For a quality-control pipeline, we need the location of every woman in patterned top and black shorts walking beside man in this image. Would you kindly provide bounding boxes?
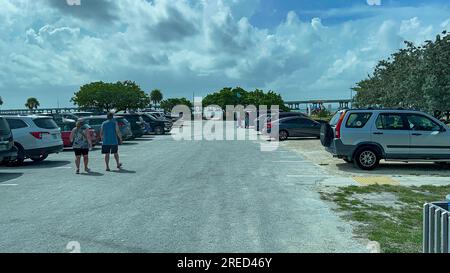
[70,121,92,174]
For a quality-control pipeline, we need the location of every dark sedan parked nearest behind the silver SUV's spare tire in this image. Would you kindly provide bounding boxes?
[264,116,321,141]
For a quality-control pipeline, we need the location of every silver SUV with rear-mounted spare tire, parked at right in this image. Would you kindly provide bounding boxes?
[320,109,450,170]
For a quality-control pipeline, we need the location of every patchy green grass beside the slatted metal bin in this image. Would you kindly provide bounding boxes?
[321,185,450,253]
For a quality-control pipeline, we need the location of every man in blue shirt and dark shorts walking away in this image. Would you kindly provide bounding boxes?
[100,112,122,172]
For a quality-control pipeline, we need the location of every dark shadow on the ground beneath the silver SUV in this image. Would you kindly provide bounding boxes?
[336,162,450,177]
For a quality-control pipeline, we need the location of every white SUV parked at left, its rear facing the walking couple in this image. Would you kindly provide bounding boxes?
[4,115,63,164]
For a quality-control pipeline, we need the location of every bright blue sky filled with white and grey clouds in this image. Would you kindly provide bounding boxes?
[0,0,450,109]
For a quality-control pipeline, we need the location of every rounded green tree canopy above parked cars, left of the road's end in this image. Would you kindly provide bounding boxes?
[72,81,150,111]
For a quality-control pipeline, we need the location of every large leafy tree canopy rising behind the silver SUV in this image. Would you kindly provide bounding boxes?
[352,31,450,116]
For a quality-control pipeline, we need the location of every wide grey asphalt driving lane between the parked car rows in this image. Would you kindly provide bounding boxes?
[0,122,367,253]
